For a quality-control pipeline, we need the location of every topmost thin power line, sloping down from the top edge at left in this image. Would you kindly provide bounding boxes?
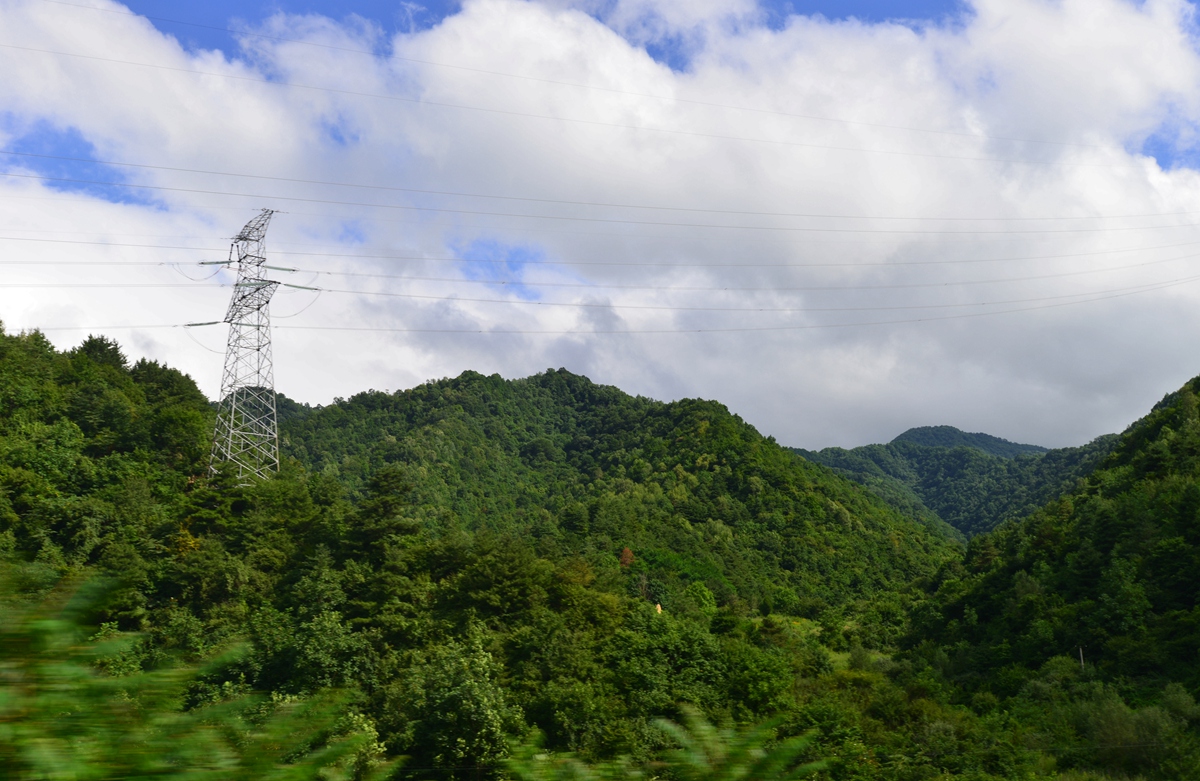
[35,0,1104,149]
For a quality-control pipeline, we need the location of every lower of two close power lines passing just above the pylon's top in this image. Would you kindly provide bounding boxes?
[0,172,1198,236]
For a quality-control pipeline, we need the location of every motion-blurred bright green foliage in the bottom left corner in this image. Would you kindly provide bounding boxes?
[0,566,389,781]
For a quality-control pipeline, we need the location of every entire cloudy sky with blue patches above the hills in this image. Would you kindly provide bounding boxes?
[0,0,1200,447]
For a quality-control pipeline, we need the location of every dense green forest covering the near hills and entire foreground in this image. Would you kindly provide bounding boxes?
[0,321,1200,781]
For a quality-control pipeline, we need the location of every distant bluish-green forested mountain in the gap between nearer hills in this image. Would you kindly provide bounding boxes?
[796,426,1117,536]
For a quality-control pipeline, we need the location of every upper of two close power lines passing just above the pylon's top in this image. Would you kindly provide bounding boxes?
[0,147,1185,222]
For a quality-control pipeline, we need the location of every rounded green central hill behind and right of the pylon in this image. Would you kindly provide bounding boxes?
[282,370,954,633]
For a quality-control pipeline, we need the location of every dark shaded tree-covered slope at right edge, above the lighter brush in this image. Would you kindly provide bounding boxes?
[925,379,1200,687]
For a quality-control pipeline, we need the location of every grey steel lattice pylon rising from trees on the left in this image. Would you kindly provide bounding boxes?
[212,209,280,482]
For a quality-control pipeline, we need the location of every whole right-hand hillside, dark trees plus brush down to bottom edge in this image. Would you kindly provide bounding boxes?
[907,379,1200,779]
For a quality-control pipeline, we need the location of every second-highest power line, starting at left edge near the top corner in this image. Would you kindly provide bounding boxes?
[0,43,1130,169]
